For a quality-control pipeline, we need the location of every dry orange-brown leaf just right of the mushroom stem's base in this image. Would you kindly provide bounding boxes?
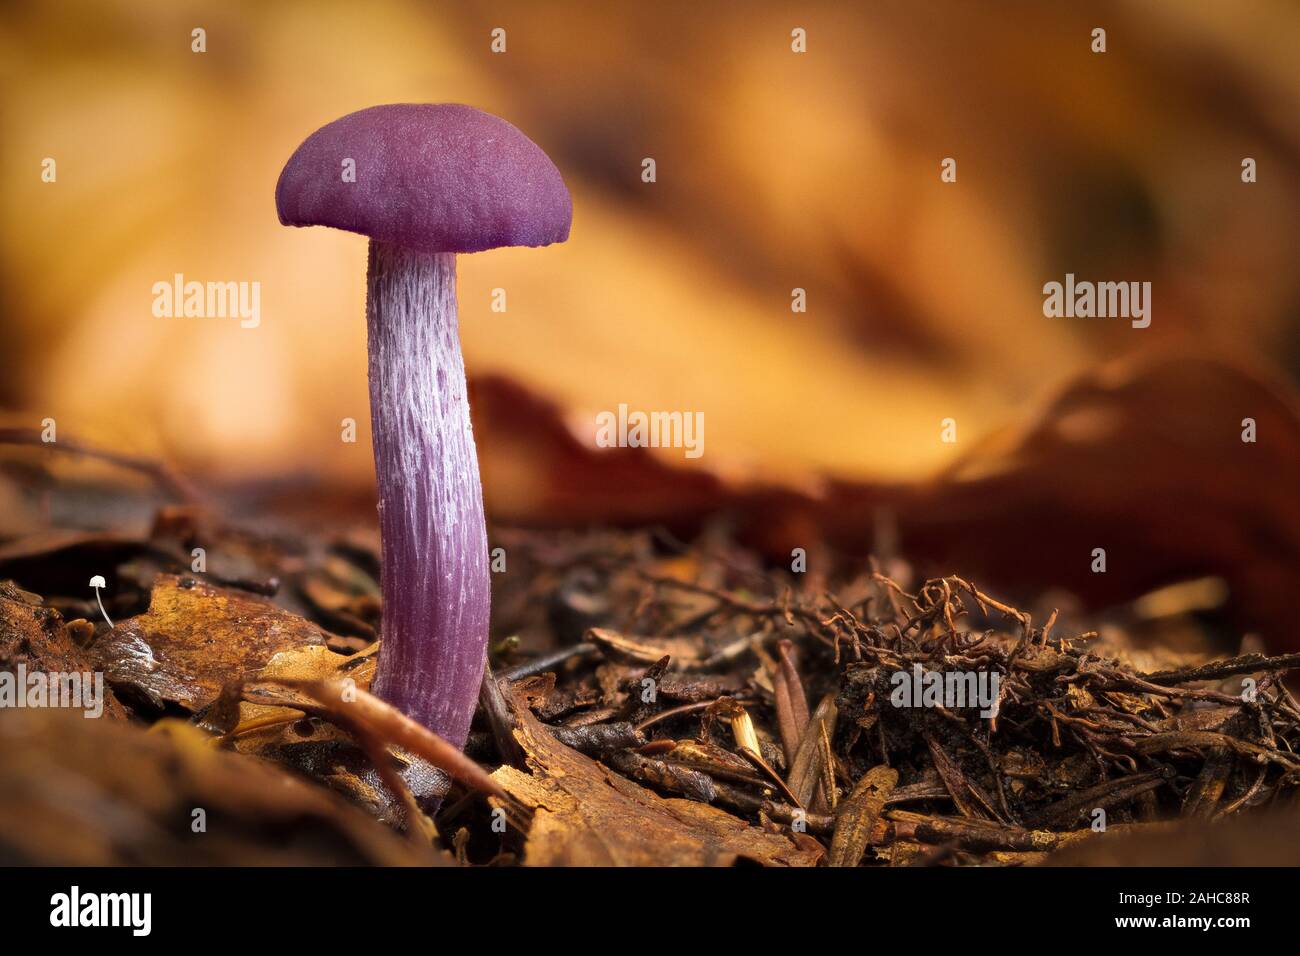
[493,697,820,866]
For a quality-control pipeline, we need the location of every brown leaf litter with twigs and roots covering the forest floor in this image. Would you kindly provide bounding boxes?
[0,510,1300,866]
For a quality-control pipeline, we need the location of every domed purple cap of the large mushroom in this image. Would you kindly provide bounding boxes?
[276,103,573,252]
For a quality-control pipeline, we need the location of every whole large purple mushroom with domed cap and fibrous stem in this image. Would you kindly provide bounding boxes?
[276,104,573,748]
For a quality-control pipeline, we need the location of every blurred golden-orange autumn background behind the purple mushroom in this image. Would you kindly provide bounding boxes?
[0,0,1300,642]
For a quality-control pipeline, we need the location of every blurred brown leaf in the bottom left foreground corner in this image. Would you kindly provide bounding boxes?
[0,710,438,866]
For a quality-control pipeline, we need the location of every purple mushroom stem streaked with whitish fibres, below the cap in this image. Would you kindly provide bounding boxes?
[365,239,491,748]
